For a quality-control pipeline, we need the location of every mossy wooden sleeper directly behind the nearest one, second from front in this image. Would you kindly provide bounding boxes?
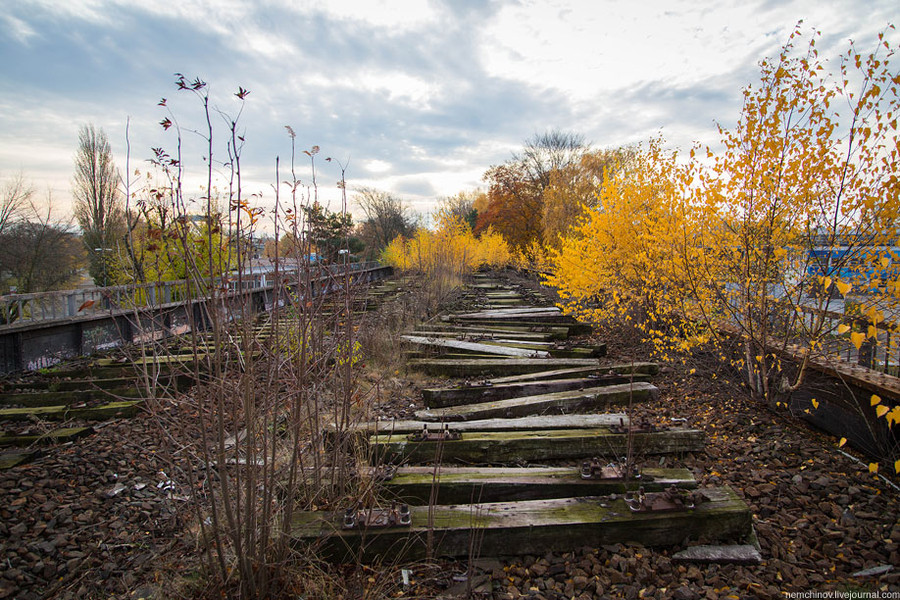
[381,466,697,504]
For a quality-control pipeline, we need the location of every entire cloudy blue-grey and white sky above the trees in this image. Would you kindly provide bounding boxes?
[0,0,897,223]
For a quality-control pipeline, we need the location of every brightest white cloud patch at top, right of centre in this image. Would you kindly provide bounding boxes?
[481,0,886,100]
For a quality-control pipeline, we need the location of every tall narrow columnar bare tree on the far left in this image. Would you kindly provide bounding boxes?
[72,124,125,286]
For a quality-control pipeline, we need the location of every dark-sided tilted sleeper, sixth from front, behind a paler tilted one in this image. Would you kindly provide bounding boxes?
[422,374,650,408]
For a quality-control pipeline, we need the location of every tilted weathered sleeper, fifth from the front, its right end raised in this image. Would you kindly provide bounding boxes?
[416,381,659,421]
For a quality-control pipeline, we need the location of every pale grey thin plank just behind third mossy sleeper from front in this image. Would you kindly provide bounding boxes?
[342,413,629,434]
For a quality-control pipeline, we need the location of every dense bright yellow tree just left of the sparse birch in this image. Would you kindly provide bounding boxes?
[547,139,702,356]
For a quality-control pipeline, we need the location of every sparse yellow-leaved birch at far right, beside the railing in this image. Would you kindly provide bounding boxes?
[689,30,900,400]
